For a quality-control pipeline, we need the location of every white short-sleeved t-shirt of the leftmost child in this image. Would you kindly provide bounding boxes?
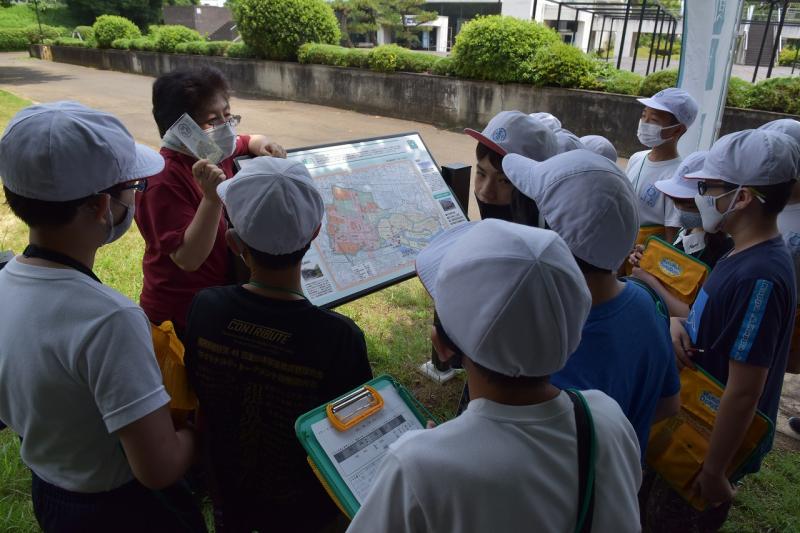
[0,259,169,492]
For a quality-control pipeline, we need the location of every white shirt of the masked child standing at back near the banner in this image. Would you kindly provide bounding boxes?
[625,150,683,228]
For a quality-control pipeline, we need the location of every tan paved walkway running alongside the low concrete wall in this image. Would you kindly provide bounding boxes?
[0,53,800,449]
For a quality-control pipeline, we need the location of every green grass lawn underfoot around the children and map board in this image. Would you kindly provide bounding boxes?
[0,91,800,532]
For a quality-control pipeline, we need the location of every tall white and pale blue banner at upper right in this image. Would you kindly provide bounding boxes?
[678,0,743,156]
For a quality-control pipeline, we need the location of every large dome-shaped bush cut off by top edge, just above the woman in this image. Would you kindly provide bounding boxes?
[233,0,341,60]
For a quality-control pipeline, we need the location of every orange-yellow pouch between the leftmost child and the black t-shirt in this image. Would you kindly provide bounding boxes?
[150,321,198,411]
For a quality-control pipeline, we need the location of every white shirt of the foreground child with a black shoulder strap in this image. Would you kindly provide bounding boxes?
[348,391,642,533]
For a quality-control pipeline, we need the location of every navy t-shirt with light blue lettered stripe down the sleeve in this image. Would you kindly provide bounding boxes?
[686,237,797,472]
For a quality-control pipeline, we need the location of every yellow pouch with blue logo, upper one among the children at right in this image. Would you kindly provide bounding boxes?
[639,237,710,305]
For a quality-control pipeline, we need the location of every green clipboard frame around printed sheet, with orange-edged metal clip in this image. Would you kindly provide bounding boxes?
[294,375,436,519]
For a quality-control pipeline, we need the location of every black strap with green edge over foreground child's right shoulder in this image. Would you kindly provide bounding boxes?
[566,389,597,533]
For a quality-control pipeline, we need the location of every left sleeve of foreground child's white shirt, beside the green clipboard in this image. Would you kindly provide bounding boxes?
[347,452,430,533]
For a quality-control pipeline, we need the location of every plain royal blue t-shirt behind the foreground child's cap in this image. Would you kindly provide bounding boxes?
[551,282,681,457]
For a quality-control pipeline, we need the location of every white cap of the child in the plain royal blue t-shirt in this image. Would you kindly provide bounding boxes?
[503,150,639,271]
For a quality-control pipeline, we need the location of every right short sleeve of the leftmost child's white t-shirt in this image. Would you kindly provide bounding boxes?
[79,308,169,433]
